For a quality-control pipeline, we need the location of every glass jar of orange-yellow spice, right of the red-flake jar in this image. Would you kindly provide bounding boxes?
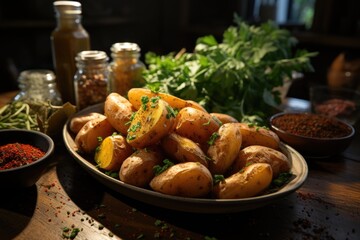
[109,42,145,96]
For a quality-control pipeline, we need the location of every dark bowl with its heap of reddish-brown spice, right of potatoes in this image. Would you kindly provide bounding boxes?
[270,112,355,157]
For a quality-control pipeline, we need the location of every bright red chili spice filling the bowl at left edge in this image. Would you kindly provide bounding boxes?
[0,143,45,170]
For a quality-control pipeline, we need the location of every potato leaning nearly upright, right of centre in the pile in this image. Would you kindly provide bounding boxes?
[207,123,242,174]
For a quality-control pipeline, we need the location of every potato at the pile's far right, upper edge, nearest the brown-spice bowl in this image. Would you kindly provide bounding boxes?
[238,123,280,149]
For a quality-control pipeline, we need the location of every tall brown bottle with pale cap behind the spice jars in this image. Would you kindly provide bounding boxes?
[51,1,90,104]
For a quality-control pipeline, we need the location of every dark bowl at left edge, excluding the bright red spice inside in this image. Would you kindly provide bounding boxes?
[0,129,54,188]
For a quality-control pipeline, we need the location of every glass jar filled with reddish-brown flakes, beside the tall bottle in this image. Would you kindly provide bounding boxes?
[74,51,109,110]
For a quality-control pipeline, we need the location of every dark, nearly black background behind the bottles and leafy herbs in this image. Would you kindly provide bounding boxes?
[0,0,360,95]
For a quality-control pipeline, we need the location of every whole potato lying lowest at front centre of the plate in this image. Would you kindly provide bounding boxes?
[150,162,213,198]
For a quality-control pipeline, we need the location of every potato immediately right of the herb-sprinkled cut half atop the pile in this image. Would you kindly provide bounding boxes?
[175,107,220,144]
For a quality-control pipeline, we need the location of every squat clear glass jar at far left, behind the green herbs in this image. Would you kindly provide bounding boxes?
[14,69,62,106]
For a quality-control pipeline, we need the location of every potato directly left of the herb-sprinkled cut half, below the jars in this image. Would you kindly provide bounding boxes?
[104,93,135,136]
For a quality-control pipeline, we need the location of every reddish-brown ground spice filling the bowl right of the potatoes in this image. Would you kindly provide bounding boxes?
[272,113,351,138]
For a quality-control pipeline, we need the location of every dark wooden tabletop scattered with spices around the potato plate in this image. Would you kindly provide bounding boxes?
[0,92,360,240]
